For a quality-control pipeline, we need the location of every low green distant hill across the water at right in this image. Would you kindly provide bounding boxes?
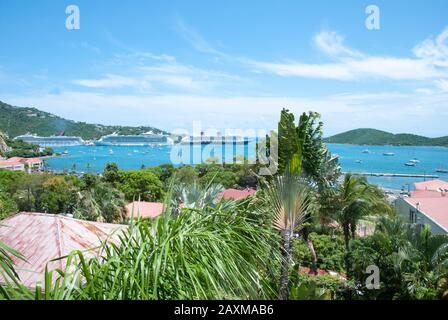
[325,129,448,147]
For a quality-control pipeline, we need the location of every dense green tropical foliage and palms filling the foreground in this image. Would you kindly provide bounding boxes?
[0,110,448,300]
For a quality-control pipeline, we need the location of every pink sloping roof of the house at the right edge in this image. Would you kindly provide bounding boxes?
[404,195,448,230]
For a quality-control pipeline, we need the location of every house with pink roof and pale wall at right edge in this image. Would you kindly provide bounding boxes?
[395,180,448,234]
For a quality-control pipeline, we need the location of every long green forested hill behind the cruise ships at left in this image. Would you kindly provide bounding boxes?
[0,101,167,140]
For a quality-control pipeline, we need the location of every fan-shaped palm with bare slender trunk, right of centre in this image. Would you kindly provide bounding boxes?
[264,174,316,300]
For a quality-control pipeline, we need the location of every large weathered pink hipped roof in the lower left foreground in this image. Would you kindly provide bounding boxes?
[0,213,126,287]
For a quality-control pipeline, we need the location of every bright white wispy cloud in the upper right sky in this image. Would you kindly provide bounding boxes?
[246,30,448,81]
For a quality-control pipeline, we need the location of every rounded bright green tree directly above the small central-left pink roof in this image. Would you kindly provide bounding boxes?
[118,169,164,201]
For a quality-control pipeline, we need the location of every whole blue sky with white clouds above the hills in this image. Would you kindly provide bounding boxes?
[0,0,448,136]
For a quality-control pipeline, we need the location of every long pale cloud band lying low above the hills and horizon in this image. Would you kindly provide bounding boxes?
[6,91,448,136]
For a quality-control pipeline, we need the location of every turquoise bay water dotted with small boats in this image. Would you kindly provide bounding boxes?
[47,142,448,190]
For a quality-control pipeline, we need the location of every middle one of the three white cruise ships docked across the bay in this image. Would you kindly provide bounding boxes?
[95,131,172,146]
